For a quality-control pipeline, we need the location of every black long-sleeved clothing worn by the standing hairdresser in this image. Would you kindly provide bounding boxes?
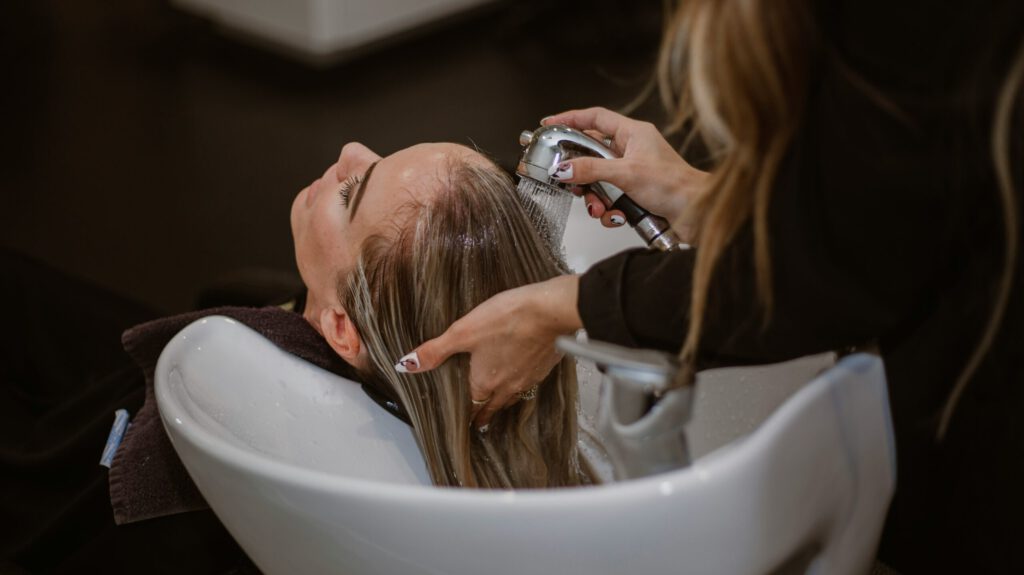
[579,0,1024,573]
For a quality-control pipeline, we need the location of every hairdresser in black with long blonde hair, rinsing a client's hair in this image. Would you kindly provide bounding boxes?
[402,0,1024,573]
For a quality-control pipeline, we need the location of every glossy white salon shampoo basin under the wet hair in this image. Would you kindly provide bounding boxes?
[156,317,895,575]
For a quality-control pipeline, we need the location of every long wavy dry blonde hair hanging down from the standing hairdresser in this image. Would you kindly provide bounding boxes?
[657,0,1024,433]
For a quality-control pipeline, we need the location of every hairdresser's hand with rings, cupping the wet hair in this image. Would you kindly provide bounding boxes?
[395,275,583,427]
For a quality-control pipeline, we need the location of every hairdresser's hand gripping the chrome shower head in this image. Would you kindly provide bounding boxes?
[541,107,708,239]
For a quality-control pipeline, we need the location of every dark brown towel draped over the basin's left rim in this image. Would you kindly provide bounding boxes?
[109,307,355,525]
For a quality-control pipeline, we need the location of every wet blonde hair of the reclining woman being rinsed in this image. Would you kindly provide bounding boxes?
[339,160,591,488]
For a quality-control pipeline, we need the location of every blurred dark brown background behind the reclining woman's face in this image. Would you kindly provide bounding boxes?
[0,0,662,312]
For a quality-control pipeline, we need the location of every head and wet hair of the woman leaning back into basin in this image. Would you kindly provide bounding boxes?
[292,144,592,488]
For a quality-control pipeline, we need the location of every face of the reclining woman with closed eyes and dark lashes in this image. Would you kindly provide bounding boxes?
[291,142,489,319]
